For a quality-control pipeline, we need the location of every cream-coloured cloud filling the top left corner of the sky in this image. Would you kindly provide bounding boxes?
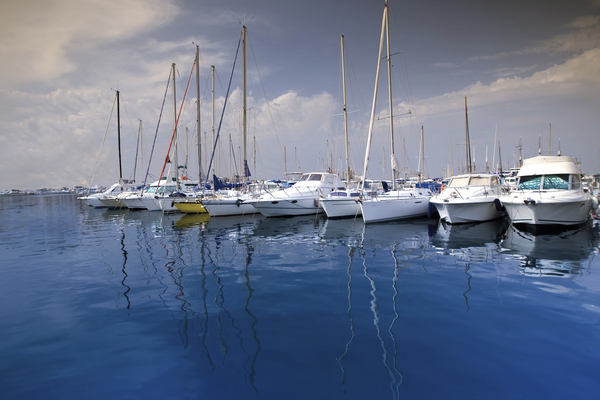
[0,0,178,87]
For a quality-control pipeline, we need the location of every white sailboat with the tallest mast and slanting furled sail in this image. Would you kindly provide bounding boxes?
[359,0,432,223]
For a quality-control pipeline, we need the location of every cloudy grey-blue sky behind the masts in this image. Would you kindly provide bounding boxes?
[0,0,600,190]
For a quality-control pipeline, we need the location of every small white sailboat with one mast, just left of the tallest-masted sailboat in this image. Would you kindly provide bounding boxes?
[320,35,362,218]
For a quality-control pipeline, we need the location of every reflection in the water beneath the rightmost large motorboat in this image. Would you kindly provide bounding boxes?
[502,221,600,278]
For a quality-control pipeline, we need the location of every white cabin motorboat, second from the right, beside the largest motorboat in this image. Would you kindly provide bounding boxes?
[430,173,506,224]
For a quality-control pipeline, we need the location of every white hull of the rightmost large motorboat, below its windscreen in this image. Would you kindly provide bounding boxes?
[503,194,592,226]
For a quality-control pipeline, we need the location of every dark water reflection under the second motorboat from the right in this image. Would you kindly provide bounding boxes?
[431,218,508,249]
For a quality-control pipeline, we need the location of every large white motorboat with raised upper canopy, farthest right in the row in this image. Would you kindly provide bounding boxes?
[500,156,593,229]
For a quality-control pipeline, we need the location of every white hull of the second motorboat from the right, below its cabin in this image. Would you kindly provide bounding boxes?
[430,198,505,224]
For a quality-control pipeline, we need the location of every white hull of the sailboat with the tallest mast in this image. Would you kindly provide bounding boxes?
[360,189,431,223]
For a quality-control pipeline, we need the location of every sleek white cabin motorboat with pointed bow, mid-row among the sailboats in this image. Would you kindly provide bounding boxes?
[244,172,345,217]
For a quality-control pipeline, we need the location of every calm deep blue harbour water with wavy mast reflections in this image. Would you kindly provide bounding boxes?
[0,195,600,399]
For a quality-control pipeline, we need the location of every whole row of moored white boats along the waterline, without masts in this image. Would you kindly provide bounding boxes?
[81,156,600,233]
